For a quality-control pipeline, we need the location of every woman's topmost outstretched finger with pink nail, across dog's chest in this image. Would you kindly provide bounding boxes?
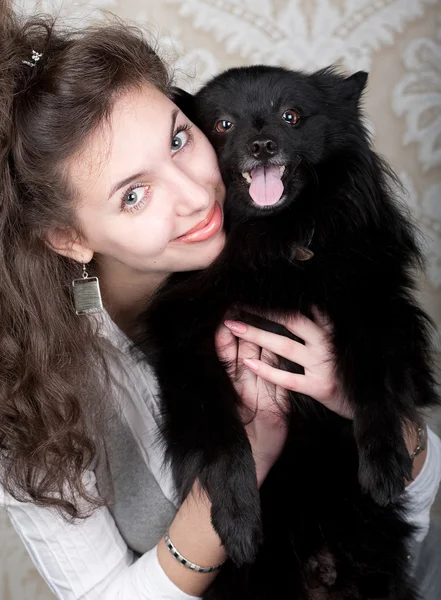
[225,321,309,367]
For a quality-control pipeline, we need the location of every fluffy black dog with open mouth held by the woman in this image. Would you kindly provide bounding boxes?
[138,66,437,600]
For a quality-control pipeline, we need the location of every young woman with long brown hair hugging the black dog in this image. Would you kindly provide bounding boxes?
[0,6,441,600]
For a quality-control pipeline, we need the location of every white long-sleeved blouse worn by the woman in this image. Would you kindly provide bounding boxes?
[0,313,441,600]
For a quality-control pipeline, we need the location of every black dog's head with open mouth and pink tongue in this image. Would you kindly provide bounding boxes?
[174,66,367,213]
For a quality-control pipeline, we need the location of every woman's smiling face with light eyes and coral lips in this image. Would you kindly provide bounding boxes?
[68,85,225,276]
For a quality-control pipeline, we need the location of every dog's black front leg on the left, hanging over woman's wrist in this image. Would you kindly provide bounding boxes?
[137,278,262,565]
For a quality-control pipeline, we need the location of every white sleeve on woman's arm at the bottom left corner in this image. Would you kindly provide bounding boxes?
[0,471,201,600]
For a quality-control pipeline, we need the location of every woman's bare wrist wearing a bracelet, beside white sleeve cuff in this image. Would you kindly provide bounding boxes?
[158,483,227,596]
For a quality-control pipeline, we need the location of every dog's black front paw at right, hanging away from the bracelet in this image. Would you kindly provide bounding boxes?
[358,443,412,506]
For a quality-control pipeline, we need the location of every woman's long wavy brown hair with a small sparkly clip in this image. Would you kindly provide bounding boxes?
[0,0,170,518]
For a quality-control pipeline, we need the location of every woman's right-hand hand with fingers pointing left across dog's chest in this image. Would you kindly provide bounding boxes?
[219,310,353,419]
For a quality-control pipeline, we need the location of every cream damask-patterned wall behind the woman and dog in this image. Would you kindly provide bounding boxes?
[0,0,441,600]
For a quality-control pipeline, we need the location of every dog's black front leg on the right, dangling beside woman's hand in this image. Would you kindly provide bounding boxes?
[331,299,436,505]
